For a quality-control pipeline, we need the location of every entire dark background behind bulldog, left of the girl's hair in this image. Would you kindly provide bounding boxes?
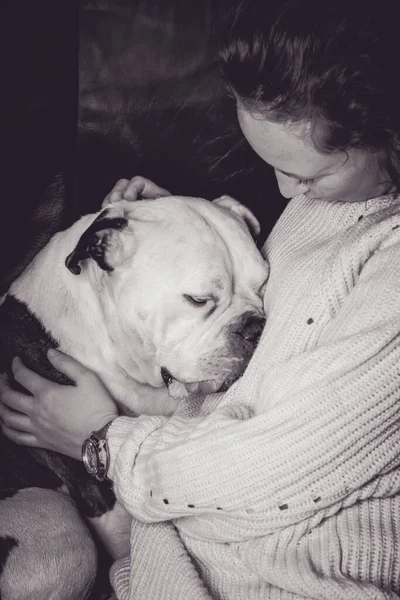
[0,0,285,295]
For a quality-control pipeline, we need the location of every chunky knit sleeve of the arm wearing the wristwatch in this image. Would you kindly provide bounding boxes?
[106,227,400,541]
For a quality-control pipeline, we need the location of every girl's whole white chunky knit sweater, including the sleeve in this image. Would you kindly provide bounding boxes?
[108,196,400,600]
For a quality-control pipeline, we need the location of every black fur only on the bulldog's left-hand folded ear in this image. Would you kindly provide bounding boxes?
[65,209,127,275]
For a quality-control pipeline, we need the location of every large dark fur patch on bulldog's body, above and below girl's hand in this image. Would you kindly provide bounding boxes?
[0,295,115,517]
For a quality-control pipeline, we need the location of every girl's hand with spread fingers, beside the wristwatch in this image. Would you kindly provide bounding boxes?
[0,350,118,460]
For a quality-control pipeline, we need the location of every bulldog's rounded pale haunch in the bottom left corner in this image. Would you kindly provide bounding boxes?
[0,488,97,600]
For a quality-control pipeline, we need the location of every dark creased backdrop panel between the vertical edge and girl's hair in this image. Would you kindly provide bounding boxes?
[79,0,285,236]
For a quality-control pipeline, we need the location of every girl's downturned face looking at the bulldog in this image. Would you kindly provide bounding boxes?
[238,106,391,202]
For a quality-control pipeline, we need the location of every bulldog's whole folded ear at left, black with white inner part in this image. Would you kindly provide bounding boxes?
[65,209,133,275]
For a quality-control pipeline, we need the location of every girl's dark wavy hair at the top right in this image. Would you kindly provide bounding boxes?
[220,0,400,191]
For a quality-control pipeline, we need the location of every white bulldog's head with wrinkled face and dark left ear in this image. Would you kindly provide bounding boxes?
[66,196,268,396]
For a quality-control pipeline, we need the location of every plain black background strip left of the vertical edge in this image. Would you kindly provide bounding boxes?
[0,0,79,295]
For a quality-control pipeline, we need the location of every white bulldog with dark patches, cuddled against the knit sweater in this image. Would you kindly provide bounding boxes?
[0,178,268,600]
